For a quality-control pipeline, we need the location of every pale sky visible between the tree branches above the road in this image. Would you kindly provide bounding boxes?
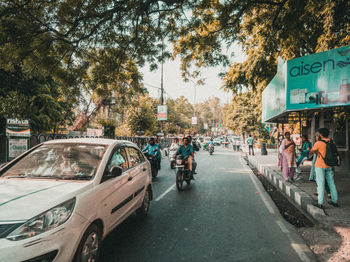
[141,45,246,103]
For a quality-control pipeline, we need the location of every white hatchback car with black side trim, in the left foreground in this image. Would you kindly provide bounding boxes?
[0,138,152,262]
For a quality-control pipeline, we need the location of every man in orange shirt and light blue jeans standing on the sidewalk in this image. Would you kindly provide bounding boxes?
[310,128,339,208]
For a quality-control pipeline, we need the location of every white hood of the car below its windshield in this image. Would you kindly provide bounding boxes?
[0,178,92,222]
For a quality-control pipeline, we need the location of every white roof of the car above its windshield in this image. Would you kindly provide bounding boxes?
[44,137,135,146]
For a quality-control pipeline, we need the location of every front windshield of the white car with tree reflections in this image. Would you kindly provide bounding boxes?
[1,143,107,180]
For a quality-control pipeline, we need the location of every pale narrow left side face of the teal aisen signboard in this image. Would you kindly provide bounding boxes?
[262,57,286,122]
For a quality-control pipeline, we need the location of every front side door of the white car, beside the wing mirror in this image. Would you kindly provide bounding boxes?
[99,145,133,231]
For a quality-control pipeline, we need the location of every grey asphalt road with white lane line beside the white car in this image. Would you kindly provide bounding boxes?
[102,147,313,262]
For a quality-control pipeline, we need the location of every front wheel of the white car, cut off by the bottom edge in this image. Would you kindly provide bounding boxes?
[74,224,102,262]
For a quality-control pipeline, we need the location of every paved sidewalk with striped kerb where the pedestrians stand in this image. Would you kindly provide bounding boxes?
[243,144,350,225]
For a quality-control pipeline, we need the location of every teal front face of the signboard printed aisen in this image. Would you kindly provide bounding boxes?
[286,45,350,110]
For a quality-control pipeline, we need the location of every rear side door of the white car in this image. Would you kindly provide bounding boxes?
[127,146,150,209]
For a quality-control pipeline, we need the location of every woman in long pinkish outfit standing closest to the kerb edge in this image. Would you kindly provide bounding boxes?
[280,132,297,182]
